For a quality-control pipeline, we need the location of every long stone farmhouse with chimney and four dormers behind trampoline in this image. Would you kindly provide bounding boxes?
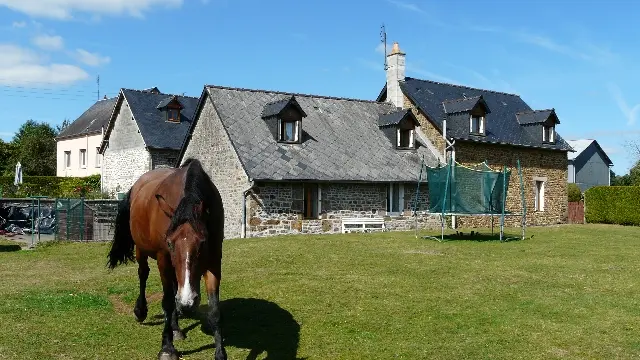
[178,43,572,238]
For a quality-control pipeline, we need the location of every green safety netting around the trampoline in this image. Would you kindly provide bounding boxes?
[425,161,511,214]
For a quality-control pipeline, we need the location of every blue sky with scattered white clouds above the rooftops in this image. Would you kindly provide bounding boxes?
[0,0,640,174]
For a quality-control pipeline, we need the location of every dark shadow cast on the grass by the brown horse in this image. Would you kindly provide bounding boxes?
[147,298,300,360]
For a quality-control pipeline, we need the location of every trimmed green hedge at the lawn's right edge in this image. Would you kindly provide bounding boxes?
[584,186,640,226]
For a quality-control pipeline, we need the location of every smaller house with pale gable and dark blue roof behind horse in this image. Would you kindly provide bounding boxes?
[99,87,198,196]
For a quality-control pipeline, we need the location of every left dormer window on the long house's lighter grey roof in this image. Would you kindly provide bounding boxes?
[261,95,307,144]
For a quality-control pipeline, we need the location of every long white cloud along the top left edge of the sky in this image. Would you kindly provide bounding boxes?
[0,0,184,20]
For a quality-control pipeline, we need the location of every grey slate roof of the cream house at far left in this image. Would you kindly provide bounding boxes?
[58,97,117,139]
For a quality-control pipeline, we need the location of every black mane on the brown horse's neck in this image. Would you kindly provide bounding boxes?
[168,158,220,237]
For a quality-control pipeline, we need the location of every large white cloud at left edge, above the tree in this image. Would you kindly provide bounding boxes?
[0,44,89,86]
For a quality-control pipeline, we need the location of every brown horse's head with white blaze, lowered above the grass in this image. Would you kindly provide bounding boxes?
[156,195,206,312]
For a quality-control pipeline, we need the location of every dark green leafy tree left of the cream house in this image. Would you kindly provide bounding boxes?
[11,120,58,176]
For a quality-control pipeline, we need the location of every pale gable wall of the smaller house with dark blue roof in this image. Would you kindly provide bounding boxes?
[102,99,151,195]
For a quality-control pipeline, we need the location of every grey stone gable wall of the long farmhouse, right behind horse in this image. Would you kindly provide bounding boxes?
[181,97,249,238]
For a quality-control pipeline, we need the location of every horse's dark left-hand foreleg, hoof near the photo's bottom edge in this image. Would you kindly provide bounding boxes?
[158,256,178,360]
